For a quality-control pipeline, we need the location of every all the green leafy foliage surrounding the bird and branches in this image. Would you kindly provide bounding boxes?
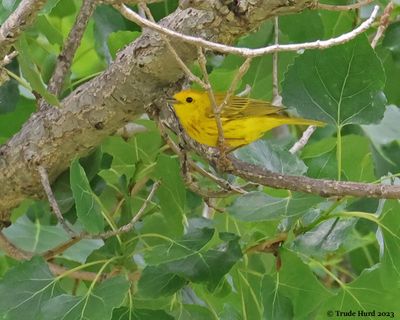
[0,0,400,320]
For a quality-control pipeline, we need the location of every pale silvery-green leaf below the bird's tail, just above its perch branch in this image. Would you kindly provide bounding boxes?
[235,140,307,175]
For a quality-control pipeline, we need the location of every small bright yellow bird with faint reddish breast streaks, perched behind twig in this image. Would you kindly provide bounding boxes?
[171,89,325,148]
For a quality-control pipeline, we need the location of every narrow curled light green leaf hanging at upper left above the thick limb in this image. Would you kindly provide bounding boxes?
[17,36,60,106]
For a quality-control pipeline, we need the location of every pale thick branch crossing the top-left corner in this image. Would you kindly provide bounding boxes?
[0,0,47,60]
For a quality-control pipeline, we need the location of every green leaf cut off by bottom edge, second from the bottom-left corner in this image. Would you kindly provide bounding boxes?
[42,277,129,320]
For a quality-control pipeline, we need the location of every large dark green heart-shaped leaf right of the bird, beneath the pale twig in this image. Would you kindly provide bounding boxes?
[282,36,386,126]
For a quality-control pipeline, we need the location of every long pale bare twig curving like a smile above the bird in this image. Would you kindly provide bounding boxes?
[119,5,379,57]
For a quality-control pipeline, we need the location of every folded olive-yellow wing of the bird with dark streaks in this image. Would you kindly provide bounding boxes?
[209,93,285,118]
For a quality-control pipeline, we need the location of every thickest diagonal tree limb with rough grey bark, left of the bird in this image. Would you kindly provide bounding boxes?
[0,0,312,221]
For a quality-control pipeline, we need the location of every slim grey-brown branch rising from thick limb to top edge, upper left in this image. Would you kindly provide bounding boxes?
[47,0,97,96]
